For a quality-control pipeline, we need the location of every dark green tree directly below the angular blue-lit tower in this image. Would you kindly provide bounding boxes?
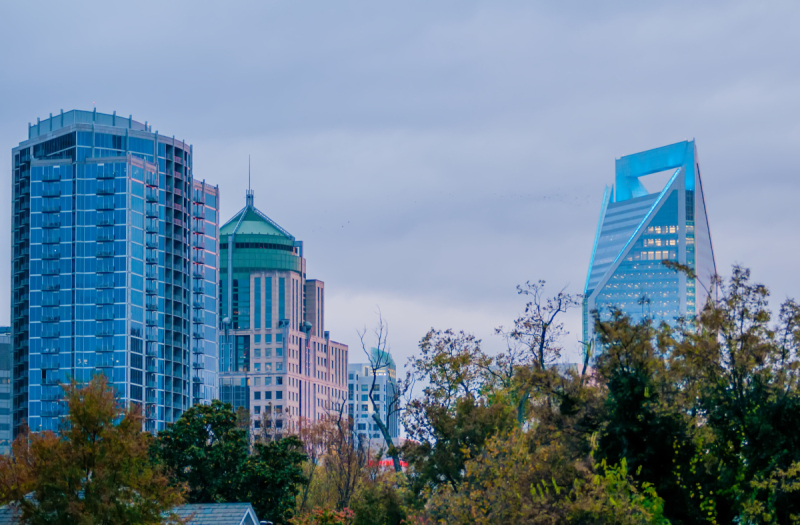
[595,312,711,523]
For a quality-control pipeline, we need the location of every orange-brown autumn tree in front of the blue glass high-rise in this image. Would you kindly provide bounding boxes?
[0,375,183,525]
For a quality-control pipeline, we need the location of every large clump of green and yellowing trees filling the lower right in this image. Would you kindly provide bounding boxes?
[356,265,800,524]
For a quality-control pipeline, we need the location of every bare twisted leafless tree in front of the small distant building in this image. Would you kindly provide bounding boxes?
[358,311,402,473]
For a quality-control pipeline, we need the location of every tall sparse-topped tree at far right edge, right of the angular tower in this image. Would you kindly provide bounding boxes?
[670,267,800,523]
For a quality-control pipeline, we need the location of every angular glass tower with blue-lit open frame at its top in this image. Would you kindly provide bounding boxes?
[583,140,716,342]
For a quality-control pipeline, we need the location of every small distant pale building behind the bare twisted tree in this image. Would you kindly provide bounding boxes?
[347,348,400,447]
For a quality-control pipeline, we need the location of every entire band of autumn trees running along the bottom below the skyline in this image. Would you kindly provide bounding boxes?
[6,264,800,525]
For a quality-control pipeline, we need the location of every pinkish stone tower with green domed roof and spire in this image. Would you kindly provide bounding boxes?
[219,190,347,434]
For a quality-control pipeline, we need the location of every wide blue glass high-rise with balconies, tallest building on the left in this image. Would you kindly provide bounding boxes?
[11,110,219,431]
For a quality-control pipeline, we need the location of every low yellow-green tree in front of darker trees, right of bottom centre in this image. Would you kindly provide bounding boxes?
[411,428,668,525]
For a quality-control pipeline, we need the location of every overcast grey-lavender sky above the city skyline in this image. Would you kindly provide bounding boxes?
[0,0,800,370]
